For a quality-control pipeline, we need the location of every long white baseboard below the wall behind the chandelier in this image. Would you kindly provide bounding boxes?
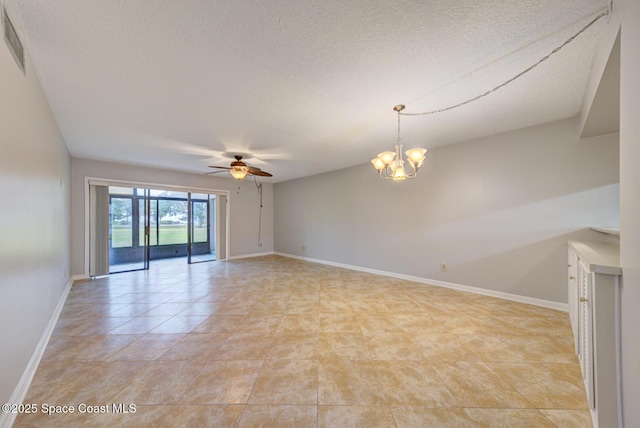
[273,251,569,312]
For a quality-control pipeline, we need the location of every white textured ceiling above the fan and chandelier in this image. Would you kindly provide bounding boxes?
[4,0,608,183]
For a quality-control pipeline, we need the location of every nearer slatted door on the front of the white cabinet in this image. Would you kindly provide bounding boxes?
[578,261,595,409]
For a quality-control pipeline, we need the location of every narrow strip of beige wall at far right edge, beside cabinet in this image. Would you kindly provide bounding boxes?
[614,0,640,427]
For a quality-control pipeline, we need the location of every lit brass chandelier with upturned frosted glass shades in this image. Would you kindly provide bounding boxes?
[371,104,427,181]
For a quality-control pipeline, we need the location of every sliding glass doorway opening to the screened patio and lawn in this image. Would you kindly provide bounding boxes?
[89,182,227,276]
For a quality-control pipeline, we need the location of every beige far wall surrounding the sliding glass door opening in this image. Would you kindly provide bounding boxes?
[71,158,273,276]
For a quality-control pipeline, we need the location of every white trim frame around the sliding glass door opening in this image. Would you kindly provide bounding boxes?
[84,177,231,278]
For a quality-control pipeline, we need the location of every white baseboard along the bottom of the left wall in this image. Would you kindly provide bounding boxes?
[0,279,73,427]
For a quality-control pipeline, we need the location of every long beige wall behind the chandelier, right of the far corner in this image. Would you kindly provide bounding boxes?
[274,119,619,303]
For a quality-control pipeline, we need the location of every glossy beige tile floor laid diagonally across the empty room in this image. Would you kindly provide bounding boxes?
[15,256,591,428]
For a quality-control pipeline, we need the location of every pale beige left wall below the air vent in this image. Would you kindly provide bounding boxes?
[0,47,71,404]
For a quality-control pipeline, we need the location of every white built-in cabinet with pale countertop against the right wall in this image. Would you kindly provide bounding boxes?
[568,241,622,428]
